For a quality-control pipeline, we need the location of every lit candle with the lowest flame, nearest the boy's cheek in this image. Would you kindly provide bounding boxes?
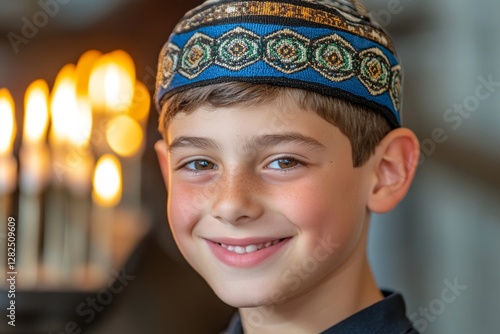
[90,154,122,278]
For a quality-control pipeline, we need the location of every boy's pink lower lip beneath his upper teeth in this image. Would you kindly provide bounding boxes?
[207,238,290,268]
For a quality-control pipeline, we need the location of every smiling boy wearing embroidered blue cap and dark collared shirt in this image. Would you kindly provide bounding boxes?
[155,0,419,334]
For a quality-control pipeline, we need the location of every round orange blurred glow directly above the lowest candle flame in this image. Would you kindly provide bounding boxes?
[106,115,144,157]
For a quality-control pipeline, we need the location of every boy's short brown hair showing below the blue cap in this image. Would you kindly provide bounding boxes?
[159,82,391,167]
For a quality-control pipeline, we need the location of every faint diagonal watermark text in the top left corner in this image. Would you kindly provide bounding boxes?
[7,0,71,54]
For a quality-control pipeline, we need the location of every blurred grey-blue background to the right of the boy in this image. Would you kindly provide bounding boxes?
[366,0,500,334]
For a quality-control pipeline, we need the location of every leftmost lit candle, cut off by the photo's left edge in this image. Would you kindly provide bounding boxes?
[0,88,17,276]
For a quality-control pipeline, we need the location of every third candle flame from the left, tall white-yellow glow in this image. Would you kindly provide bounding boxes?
[50,64,78,142]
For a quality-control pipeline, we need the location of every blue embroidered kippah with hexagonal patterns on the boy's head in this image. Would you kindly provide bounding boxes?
[155,0,402,127]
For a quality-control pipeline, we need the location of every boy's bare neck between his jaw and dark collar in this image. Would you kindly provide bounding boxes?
[239,227,383,334]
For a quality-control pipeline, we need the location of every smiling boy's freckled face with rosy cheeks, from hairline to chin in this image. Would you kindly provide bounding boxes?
[163,102,374,307]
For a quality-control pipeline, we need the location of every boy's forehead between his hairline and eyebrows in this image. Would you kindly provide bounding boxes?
[166,102,346,149]
